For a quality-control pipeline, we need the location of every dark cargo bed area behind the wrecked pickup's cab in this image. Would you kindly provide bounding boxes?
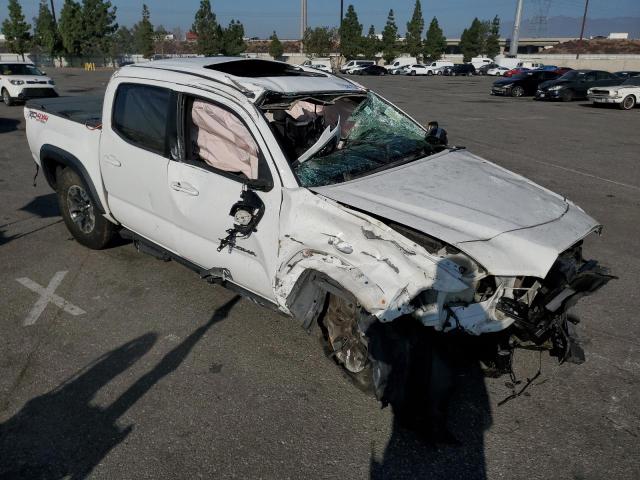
[26,95,103,126]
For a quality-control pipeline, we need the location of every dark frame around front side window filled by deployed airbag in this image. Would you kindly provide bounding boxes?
[176,92,274,192]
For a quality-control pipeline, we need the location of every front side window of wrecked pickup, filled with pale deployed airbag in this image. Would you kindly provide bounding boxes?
[185,98,260,180]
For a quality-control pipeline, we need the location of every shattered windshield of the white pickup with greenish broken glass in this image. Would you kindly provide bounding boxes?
[262,92,439,187]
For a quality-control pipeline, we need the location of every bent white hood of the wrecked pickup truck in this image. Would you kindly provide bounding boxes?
[311,150,598,277]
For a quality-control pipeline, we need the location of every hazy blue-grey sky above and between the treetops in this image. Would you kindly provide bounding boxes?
[0,0,640,38]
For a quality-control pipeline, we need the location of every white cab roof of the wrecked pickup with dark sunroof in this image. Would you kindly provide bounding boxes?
[122,57,364,94]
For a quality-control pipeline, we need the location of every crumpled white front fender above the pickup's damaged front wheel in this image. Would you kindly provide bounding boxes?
[274,188,469,321]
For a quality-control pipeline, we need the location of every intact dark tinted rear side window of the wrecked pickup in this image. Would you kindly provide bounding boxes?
[112,83,171,156]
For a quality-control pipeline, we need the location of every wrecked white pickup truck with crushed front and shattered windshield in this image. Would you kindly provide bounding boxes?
[25,57,610,424]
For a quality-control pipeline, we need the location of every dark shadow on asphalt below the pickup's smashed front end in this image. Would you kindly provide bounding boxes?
[370,361,492,480]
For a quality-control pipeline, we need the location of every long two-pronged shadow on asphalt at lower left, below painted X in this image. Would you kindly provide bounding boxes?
[0,296,240,480]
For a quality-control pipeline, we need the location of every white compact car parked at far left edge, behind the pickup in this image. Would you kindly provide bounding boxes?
[0,62,58,106]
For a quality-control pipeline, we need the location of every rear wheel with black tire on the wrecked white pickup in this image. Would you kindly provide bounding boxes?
[56,168,116,250]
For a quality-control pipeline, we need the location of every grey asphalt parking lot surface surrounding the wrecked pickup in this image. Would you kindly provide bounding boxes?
[0,70,640,480]
